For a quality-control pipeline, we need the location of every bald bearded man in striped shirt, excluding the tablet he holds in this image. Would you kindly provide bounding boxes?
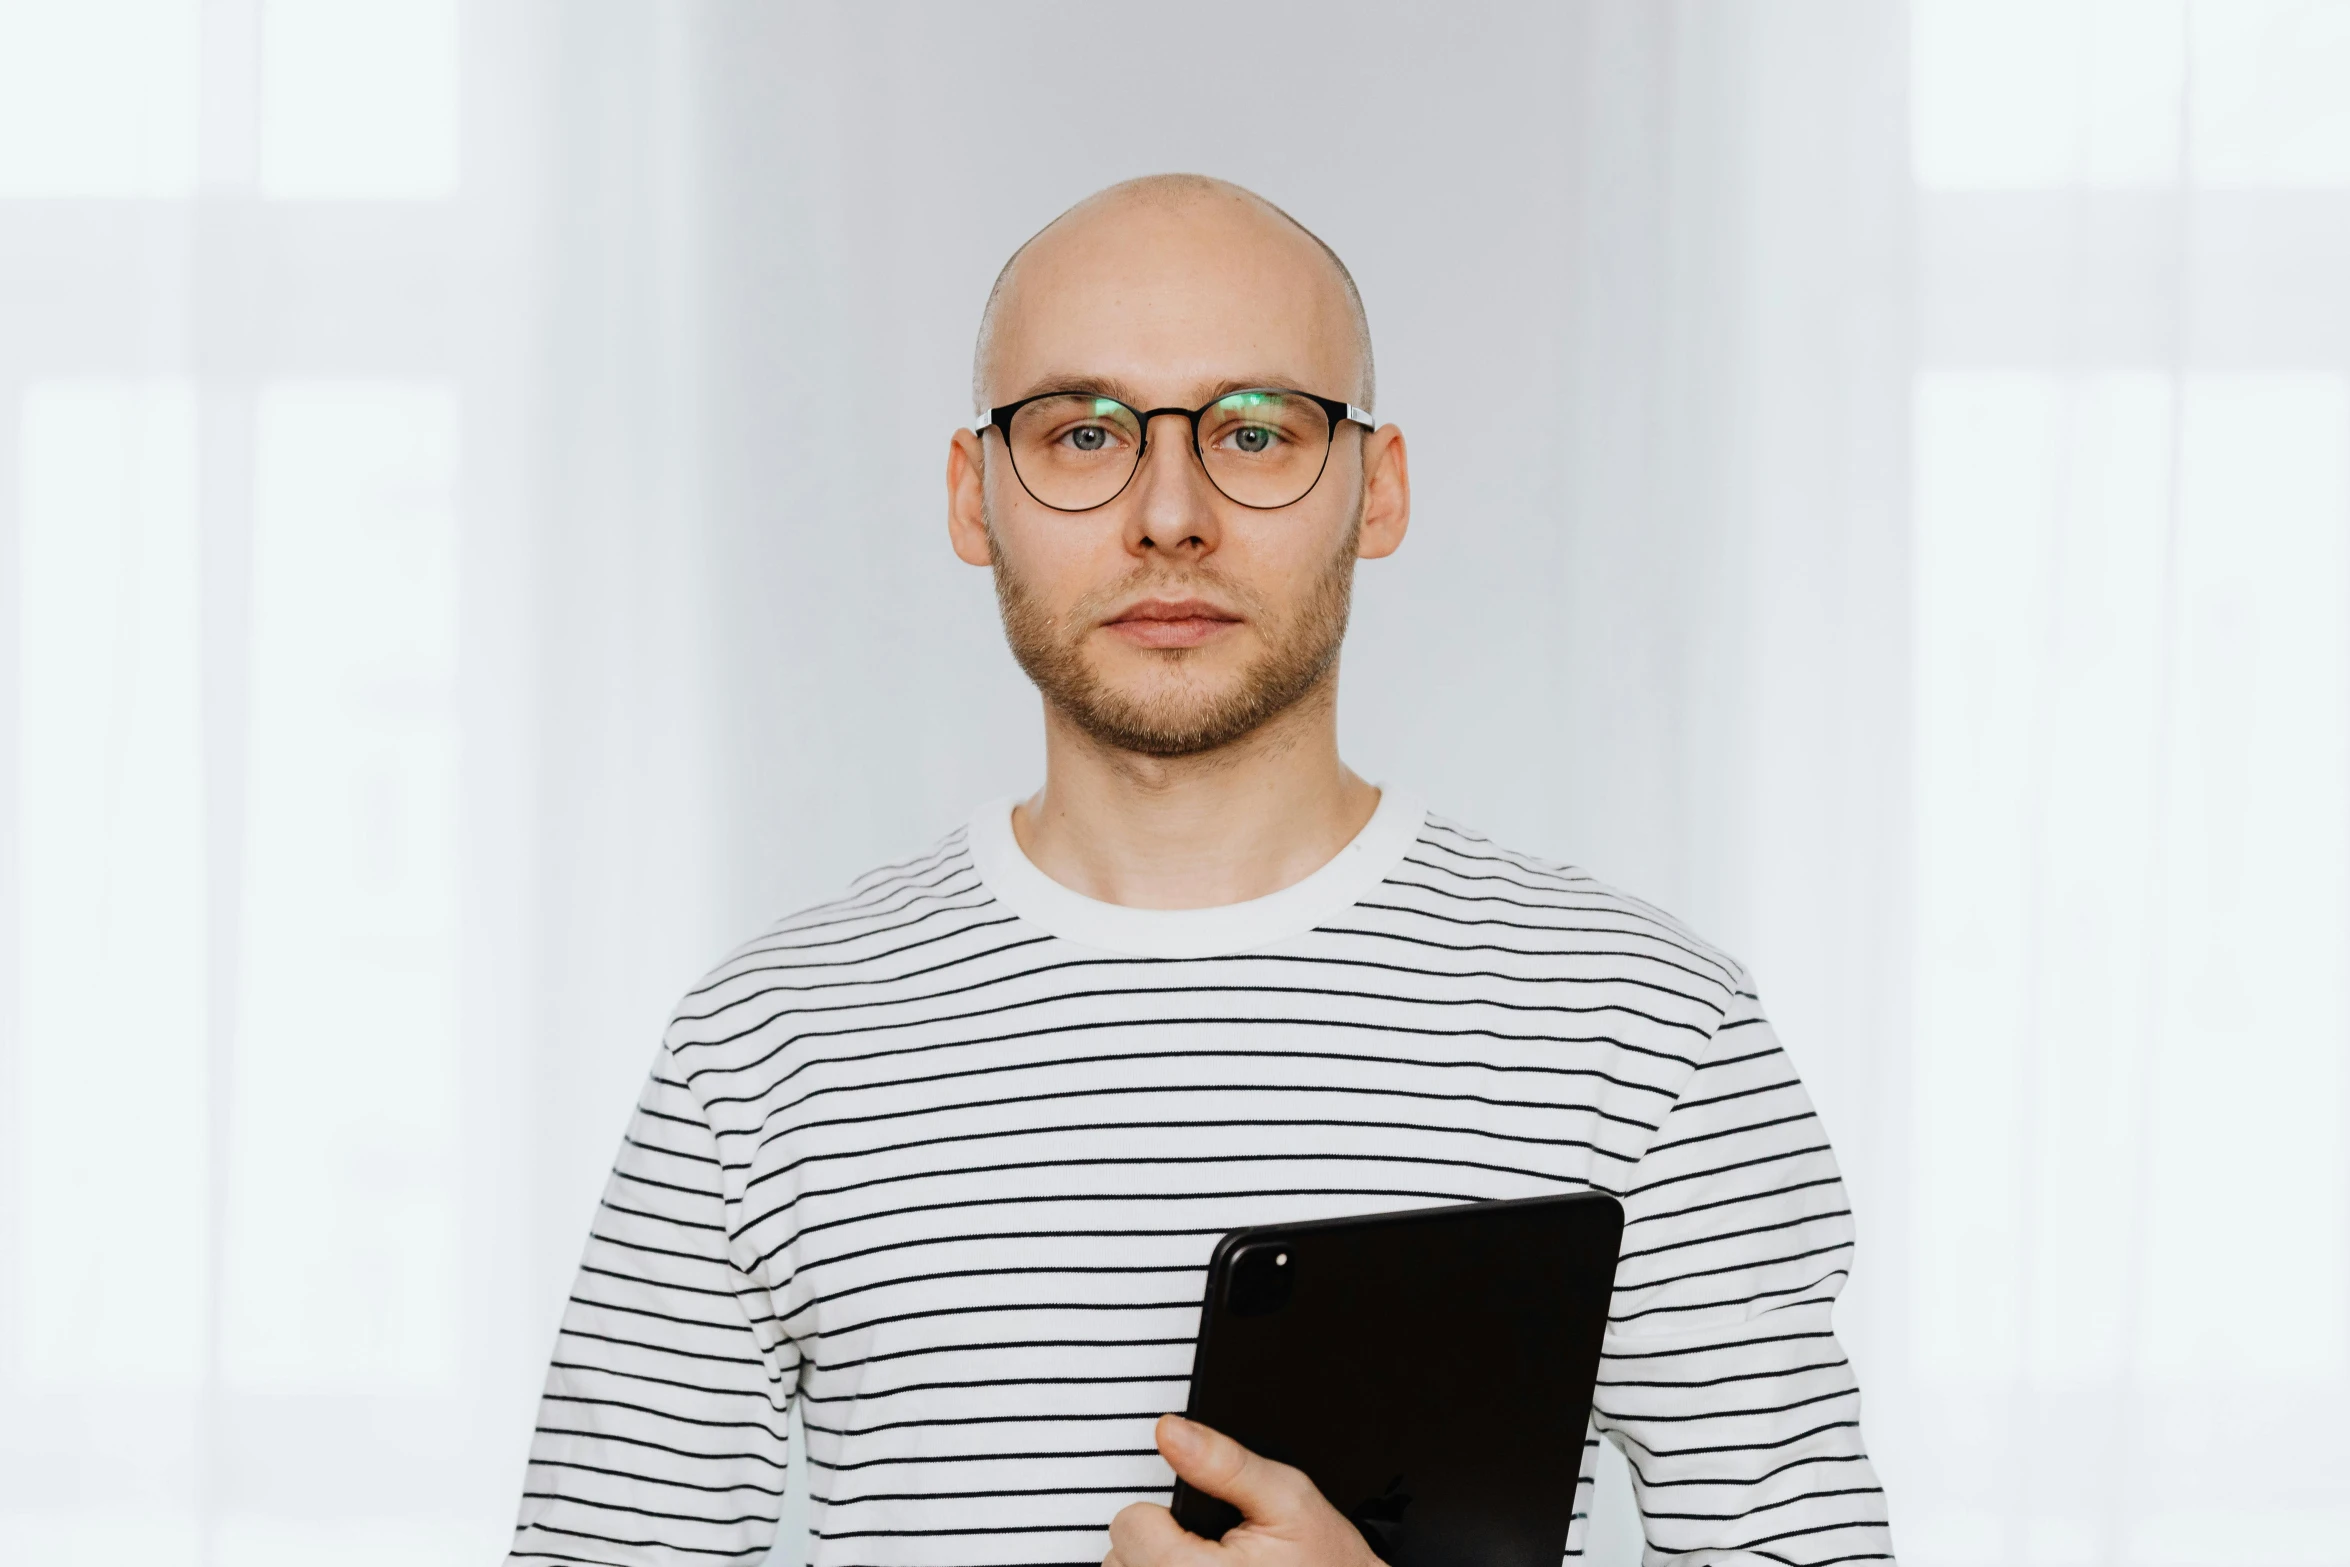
[512,176,1889,1567]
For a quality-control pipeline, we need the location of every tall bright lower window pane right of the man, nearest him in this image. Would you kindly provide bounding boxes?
[1913,374,2171,1381]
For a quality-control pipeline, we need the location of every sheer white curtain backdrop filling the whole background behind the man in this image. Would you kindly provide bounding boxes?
[0,0,2350,1565]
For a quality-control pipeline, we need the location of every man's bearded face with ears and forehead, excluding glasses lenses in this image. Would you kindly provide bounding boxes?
[947,195,1410,756]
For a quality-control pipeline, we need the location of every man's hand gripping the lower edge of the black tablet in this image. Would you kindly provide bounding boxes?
[1102,1414,1384,1567]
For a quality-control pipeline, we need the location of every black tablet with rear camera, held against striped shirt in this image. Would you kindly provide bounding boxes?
[1175,1191,1624,1567]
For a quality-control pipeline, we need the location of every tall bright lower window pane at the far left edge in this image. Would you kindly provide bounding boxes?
[7,383,209,1388]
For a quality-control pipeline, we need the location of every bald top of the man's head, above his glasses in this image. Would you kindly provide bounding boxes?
[971,174,1377,413]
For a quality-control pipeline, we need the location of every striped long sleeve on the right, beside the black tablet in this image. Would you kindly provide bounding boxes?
[1593,977,1892,1567]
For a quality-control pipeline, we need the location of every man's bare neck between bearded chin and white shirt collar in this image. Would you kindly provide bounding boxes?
[1013,670,1379,909]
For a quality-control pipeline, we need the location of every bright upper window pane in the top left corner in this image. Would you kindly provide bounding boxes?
[0,0,200,197]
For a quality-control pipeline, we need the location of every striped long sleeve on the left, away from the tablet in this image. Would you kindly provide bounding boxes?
[508,1050,799,1567]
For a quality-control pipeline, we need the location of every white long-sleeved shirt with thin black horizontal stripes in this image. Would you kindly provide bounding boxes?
[510,789,1892,1567]
